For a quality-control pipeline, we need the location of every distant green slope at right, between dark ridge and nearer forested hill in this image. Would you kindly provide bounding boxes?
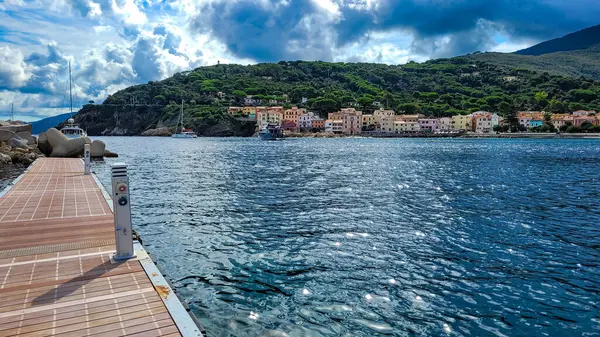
[464,44,600,80]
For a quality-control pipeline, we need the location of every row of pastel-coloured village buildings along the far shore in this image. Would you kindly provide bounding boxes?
[227,106,600,136]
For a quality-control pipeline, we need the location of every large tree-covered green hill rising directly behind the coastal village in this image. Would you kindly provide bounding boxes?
[77,57,600,134]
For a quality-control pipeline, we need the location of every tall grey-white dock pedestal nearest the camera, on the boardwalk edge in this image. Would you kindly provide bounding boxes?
[112,163,135,261]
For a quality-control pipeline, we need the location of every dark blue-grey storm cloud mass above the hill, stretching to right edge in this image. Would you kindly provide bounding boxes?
[192,0,600,61]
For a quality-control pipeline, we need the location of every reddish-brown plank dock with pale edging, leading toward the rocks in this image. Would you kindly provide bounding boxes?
[0,158,202,337]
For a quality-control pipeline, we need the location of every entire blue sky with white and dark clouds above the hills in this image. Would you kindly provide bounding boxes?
[0,0,600,121]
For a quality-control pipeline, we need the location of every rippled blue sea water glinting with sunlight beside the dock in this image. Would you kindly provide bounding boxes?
[94,137,600,336]
